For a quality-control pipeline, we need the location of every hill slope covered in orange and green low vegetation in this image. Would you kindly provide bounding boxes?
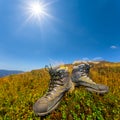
[0,62,120,120]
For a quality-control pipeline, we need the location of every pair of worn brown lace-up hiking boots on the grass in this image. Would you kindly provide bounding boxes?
[33,64,108,116]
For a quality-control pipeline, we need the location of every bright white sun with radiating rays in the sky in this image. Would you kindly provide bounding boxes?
[24,0,53,23]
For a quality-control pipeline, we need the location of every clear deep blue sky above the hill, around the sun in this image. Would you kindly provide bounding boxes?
[0,0,120,71]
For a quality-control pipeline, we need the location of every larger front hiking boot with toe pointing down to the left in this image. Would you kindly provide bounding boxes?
[33,67,72,116]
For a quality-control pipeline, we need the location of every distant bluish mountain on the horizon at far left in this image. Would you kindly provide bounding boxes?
[0,70,23,77]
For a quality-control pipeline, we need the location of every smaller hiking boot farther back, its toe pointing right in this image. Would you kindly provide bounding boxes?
[72,64,109,94]
